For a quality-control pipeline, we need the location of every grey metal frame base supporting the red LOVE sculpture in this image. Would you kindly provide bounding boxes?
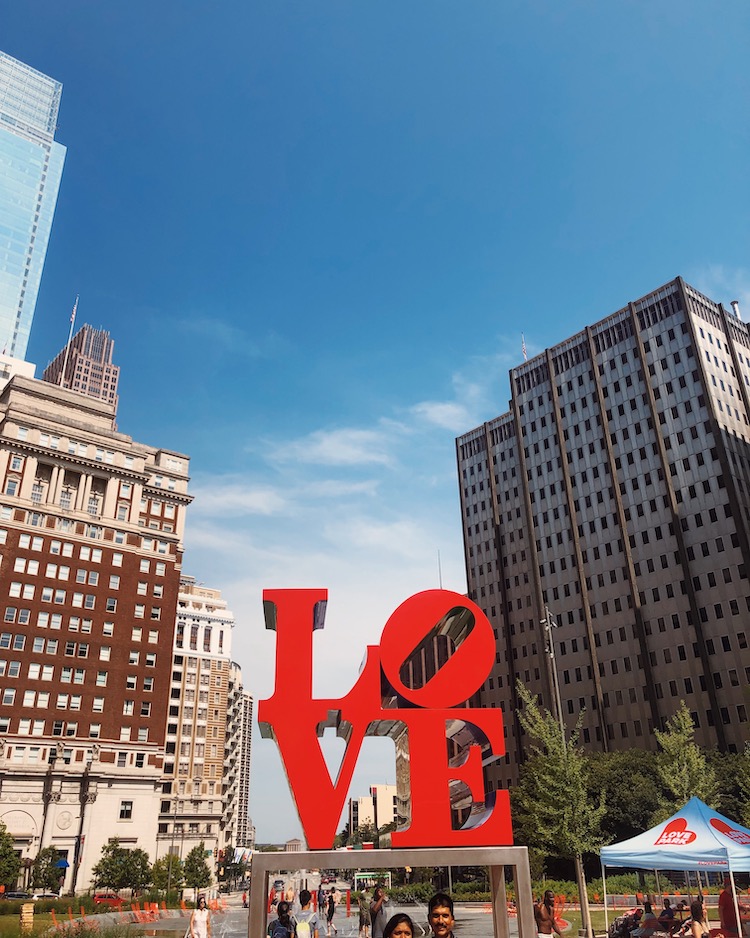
[247,847,536,938]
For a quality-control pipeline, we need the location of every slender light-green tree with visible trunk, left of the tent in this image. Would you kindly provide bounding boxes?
[515,681,605,938]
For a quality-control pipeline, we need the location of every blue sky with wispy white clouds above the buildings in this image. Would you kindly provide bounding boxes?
[0,0,750,841]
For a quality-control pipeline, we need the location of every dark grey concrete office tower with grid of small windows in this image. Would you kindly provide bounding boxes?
[457,278,750,787]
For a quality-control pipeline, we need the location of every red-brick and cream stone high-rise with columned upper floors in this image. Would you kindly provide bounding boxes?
[0,376,191,889]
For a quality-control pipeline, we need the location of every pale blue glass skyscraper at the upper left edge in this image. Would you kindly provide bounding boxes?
[0,52,65,358]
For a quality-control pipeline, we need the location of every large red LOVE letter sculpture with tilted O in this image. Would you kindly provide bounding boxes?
[258,589,513,850]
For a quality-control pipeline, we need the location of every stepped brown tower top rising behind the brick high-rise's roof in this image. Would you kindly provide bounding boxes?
[42,325,120,410]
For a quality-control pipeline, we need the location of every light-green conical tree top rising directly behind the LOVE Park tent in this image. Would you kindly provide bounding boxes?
[651,700,719,824]
